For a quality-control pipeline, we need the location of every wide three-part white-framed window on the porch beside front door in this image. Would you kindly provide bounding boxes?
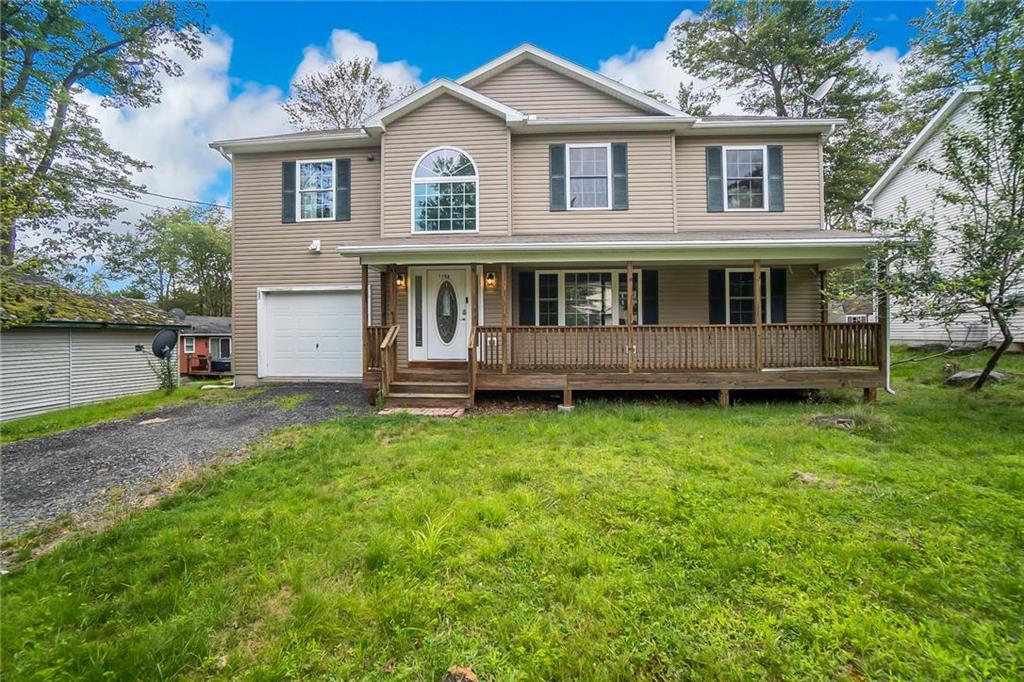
[536,270,641,327]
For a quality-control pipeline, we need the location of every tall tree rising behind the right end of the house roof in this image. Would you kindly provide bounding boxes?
[671,0,895,227]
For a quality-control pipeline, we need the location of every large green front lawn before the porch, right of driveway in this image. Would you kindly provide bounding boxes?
[0,348,1024,680]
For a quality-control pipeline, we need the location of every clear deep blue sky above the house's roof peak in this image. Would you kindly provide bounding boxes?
[210,2,926,87]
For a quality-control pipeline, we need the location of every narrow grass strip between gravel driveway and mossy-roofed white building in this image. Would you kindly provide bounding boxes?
[0,382,239,444]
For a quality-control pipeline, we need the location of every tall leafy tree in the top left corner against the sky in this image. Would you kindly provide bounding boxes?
[0,0,206,276]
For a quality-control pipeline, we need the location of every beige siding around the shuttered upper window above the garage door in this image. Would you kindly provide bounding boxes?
[231,148,381,381]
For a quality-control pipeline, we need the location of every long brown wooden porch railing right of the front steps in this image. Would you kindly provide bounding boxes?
[473,323,881,372]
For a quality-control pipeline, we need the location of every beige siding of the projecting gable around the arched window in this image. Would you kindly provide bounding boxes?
[382,95,509,238]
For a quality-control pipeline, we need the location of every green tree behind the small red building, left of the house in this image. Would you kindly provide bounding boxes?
[105,208,231,315]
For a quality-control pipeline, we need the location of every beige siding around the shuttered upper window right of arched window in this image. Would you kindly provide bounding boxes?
[512,133,673,235]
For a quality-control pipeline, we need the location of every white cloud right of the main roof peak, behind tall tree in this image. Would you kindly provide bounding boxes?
[599,9,901,114]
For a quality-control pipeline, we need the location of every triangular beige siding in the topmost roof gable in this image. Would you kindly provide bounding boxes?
[471,59,650,118]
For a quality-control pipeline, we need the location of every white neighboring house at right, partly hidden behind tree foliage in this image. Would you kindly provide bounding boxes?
[861,86,1024,346]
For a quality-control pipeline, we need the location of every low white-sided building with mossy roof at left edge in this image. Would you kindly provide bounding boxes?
[0,270,183,421]
